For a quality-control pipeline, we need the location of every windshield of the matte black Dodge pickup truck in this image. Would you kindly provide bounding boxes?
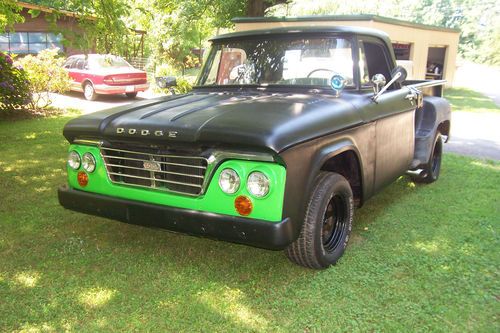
[197,37,354,87]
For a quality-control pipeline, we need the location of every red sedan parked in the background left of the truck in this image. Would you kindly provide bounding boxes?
[64,54,149,101]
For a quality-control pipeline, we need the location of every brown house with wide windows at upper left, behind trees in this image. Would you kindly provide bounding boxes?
[0,2,88,54]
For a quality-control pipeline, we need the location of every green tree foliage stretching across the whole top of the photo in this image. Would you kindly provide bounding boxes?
[13,0,500,67]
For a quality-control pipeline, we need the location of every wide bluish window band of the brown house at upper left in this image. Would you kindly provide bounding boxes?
[0,32,64,54]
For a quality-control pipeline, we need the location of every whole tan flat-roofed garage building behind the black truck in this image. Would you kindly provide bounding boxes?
[233,15,460,86]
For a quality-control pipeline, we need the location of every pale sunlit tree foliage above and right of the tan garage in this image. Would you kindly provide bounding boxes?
[270,0,500,64]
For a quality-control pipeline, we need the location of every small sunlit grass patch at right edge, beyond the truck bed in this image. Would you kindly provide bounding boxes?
[444,88,500,112]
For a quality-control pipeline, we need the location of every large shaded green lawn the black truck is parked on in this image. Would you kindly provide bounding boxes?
[0,118,500,332]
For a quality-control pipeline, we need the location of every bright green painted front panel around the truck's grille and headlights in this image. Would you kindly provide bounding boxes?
[67,145,286,222]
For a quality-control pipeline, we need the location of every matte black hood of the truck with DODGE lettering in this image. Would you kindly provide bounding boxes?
[64,92,362,152]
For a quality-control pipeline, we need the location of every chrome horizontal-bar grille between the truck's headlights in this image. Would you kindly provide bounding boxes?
[100,146,208,196]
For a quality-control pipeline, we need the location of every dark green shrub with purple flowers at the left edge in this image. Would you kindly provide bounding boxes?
[0,52,30,111]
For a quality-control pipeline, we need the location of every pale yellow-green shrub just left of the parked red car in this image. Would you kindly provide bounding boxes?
[18,49,71,110]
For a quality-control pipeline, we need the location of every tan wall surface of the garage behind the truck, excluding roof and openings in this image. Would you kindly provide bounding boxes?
[235,20,460,87]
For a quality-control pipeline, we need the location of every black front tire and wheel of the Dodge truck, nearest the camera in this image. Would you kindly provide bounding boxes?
[285,172,354,269]
